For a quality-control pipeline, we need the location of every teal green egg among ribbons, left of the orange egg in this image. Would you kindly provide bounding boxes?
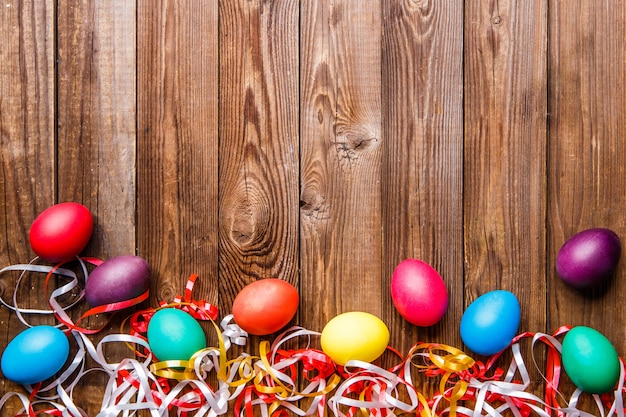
[148,308,206,361]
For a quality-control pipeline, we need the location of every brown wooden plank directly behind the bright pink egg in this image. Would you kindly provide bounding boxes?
[382,1,464,380]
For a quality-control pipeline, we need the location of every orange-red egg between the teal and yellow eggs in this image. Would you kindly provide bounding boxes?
[232,278,299,336]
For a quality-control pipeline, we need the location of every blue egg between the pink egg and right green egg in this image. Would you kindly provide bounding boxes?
[461,290,520,355]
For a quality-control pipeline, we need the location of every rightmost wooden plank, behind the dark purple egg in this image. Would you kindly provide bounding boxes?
[548,1,626,404]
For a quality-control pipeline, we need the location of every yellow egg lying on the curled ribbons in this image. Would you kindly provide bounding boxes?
[320,311,389,366]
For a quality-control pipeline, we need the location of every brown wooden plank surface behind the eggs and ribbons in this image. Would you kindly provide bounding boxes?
[0,0,626,415]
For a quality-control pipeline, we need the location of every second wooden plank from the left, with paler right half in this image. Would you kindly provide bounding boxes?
[57,0,136,415]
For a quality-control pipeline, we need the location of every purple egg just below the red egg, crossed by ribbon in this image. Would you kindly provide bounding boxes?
[85,255,150,307]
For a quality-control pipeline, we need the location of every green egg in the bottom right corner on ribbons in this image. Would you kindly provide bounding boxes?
[562,326,620,394]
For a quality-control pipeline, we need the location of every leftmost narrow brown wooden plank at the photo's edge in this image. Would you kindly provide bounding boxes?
[0,1,56,415]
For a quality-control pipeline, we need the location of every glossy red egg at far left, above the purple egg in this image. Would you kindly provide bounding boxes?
[29,202,93,263]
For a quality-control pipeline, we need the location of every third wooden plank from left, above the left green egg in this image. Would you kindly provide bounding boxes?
[137,0,218,304]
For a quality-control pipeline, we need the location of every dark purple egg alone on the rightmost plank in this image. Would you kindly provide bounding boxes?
[556,228,622,288]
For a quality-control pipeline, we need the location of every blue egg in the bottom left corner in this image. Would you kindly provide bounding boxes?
[1,325,70,385]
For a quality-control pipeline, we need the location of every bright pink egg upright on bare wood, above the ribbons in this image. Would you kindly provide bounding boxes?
[391,259,448,327]
